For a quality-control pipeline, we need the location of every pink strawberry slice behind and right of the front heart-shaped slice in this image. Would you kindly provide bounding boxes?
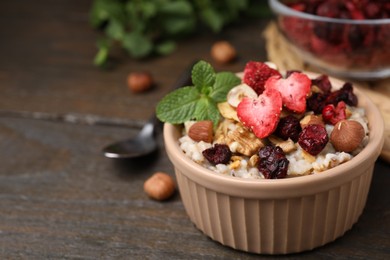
[265,72,311,113]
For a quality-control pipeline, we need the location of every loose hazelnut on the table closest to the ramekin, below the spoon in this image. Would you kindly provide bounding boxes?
[144,172,175,200]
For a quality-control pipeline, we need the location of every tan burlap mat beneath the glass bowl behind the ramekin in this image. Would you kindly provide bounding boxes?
[264,22,390,162]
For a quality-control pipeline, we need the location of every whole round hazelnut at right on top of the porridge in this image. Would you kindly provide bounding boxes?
[330,120,365,152]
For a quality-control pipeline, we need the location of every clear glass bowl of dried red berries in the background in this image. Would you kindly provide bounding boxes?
[269,0,390,79]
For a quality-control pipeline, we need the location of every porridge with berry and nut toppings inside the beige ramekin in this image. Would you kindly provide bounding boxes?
[159,61,369,179]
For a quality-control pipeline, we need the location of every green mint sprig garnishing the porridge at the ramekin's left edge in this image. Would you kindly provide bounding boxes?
[156,61,241,126]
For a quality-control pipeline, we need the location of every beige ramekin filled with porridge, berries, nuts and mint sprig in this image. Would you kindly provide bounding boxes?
[157,62,384,254]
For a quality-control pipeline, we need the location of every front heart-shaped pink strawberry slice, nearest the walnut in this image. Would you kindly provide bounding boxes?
[237,89,282,138]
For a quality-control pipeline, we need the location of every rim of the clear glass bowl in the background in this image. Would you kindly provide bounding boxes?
[268,0,390,25]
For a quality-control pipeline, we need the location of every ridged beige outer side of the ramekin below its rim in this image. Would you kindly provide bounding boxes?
[176,162,373,254]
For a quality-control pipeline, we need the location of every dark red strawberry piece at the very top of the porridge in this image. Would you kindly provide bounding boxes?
[242,61,281,95]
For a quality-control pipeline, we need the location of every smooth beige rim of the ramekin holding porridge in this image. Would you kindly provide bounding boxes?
[164,71,384,198]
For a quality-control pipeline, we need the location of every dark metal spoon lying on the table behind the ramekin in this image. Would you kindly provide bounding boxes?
[102,62,196,159]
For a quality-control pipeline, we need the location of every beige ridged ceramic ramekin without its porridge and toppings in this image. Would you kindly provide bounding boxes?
[164,73,384,254]
